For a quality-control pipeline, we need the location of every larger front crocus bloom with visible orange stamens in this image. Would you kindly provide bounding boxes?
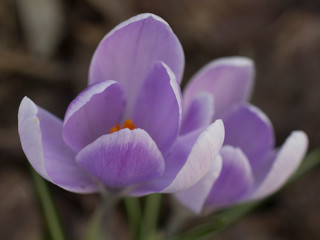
[18,14,224,196]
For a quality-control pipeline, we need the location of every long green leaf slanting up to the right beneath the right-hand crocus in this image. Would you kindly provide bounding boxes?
[168,148,320,240]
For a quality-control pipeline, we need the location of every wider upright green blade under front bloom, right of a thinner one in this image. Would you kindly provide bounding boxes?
[138,194,161,240]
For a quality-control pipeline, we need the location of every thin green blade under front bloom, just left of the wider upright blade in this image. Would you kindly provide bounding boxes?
[124,197,141,239]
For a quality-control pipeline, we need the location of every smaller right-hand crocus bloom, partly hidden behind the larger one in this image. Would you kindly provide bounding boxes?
[175,57,308,213]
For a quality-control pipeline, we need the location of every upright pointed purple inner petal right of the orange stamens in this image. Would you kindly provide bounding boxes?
[132,62,182,155]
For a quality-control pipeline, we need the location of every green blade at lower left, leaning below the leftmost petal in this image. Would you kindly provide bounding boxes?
[31,169,66,240]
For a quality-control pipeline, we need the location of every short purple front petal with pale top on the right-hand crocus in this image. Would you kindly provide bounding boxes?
[205,146,254,208]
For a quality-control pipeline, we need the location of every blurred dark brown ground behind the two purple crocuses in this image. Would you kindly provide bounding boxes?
[0,0,320,240]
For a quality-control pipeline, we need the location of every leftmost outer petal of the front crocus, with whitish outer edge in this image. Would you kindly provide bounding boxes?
[18,97,97,193]
